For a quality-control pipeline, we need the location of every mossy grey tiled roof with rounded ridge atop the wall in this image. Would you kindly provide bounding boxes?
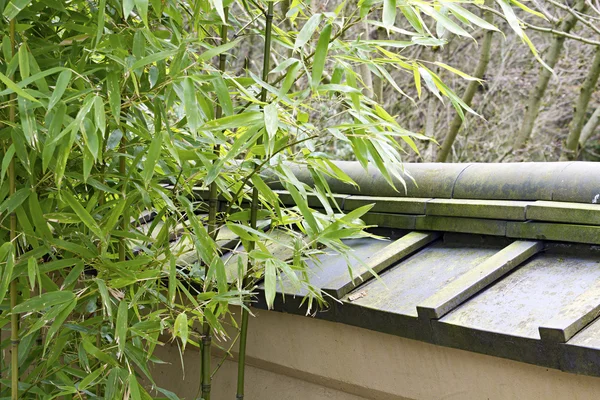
[252,162,600,376]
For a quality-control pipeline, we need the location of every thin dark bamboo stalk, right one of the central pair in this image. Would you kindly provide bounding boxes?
[235,1,273,400]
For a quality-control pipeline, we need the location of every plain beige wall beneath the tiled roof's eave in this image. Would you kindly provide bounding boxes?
[155,310,600,400]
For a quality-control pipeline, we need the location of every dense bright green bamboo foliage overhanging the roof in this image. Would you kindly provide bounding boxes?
[0,0,540,400]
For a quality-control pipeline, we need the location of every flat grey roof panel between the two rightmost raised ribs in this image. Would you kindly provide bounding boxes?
[440,253,600,339]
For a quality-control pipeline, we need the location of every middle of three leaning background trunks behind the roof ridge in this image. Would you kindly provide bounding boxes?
[513,0,587,150]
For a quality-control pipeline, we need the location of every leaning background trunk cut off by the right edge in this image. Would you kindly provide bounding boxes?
[561,46,600,160]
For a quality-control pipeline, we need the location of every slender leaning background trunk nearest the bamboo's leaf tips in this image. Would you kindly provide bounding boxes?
[437,0,494,162]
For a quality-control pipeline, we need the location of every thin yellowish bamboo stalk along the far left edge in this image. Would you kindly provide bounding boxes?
[8,18,19,400]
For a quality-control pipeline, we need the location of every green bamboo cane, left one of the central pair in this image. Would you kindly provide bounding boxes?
[200,7,229,400]
